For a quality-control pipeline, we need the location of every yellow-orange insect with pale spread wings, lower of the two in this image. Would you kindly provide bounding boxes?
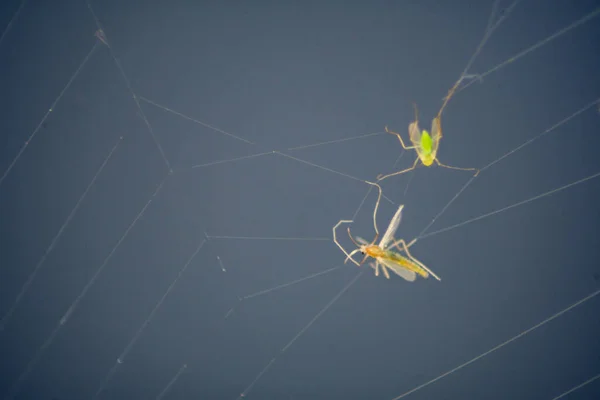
[333,182,441,282]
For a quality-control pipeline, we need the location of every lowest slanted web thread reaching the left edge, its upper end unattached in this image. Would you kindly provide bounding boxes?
[0,136,123,332]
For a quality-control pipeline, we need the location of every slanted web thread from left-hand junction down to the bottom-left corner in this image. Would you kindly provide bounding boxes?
[5,171,171,400]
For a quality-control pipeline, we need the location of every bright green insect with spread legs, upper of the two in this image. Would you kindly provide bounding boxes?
[377,101,479,181]
